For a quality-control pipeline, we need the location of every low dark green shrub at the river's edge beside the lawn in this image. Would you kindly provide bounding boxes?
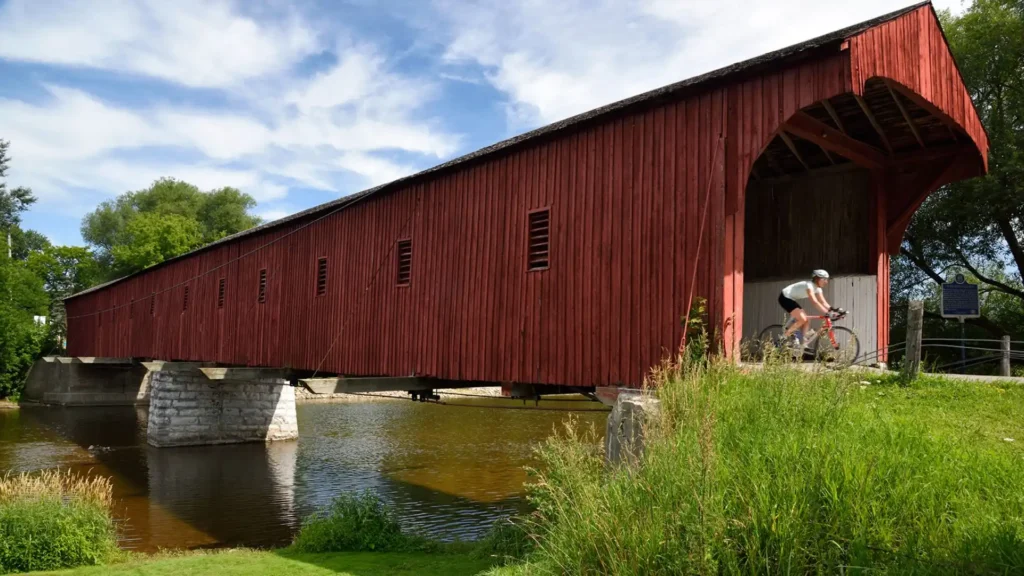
[293,492,409,552]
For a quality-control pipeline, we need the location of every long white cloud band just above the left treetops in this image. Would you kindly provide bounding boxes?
[0,81,448,213]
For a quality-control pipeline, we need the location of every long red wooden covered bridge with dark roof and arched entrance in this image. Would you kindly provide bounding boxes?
[67,3,988,386]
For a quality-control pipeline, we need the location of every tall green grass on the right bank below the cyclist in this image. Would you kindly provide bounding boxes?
[516,356,1024,574]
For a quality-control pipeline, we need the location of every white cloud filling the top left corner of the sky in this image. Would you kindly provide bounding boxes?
[0,0,319,87]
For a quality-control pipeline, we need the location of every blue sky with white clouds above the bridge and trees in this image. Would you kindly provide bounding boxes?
[0,0,963,244]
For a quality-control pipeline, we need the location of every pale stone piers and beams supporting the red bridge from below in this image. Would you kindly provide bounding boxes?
[26,357,592,448]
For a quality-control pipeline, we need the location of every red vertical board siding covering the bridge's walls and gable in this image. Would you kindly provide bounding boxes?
[68,7,983,385]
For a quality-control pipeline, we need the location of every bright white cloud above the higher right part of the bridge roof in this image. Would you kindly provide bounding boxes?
[434,0,959,129]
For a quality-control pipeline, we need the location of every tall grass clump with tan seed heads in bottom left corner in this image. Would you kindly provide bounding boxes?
[0,471,117,573]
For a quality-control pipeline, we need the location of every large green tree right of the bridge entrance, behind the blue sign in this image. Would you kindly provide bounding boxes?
[892,0,1024,350]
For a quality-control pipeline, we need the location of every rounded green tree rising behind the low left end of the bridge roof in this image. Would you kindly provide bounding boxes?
[82,178,260,278]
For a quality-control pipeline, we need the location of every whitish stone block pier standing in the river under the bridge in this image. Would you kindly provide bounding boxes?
[146,362,299,448]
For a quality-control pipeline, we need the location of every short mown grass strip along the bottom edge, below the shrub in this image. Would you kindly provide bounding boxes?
[33,550,490,576]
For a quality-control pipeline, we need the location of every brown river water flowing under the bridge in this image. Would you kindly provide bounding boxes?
[0,399,606,551]
